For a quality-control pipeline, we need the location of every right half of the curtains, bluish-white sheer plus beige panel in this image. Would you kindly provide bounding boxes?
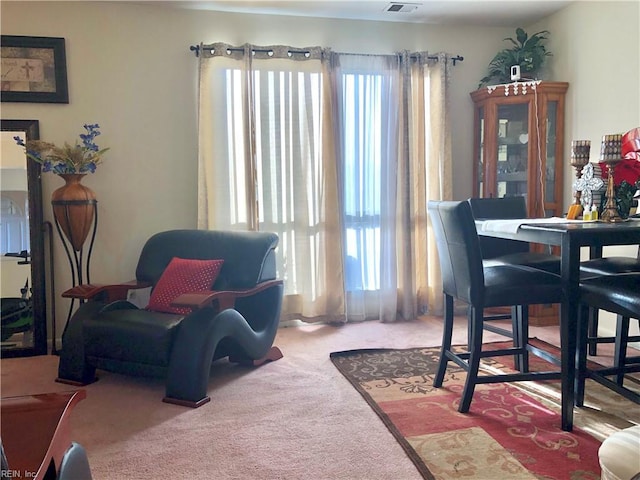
[333,52,452,322]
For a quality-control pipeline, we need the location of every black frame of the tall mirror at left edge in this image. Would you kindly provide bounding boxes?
[0,120,47,358]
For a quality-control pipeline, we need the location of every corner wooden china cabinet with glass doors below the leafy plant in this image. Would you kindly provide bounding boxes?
[471,81,569,325]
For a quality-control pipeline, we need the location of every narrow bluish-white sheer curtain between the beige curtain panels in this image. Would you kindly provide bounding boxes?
[335,54,402,321]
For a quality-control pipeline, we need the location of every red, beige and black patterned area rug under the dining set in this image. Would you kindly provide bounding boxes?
[331,342,640,480]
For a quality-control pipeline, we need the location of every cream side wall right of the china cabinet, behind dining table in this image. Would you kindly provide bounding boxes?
[542,0,640,333]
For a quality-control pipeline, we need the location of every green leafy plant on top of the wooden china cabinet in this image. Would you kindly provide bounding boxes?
[479,27,551,87]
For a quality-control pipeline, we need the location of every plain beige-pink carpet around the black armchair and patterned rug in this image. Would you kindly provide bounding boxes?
[0,318,632,480]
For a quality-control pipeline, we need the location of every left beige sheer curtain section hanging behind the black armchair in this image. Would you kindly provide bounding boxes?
[199,44,344,322]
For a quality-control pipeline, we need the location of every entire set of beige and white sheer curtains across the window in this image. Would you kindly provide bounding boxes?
[199,44,451,322]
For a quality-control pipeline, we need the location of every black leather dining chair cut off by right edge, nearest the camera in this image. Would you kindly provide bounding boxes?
[575,273,640,406]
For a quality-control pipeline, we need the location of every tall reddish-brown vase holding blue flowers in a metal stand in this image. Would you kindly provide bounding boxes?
[51,173,97,252]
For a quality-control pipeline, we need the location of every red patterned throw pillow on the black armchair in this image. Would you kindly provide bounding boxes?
[147,257,224,315]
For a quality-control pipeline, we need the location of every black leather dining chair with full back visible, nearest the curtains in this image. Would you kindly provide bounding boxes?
[428,201,562,413]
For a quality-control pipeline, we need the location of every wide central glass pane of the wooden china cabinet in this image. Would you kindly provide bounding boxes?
[496,103,529,197]
